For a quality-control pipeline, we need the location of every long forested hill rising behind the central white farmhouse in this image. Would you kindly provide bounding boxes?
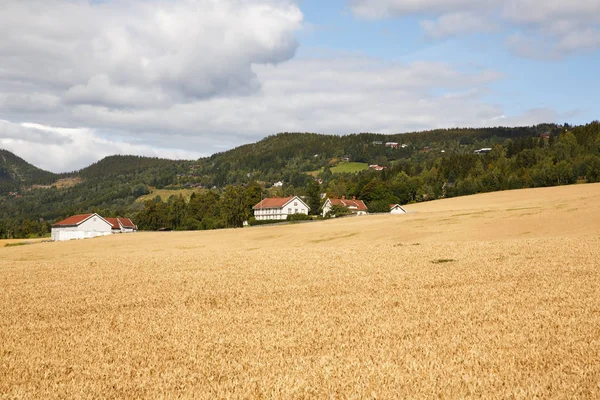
[198,124,564,186]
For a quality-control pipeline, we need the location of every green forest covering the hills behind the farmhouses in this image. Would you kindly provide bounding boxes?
[0,121,600,238]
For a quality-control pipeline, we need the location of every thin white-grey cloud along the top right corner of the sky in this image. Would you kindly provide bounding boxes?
[349,0,600,59]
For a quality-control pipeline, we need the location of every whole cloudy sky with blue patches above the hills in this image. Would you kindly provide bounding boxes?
[0,0,600,172]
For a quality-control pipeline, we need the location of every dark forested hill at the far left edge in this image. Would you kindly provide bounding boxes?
[0,149,57,195]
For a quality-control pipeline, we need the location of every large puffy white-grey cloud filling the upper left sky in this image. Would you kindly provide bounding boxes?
[0,0,302,107]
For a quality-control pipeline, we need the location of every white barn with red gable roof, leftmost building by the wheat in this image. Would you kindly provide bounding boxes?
[52,213,113,241]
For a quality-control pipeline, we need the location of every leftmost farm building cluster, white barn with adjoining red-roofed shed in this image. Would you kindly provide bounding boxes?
[52,213,137,242]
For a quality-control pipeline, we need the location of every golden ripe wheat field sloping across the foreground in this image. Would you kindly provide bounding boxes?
[0,184,600,399]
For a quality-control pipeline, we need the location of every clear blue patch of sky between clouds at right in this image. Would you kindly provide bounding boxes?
[299,0,600,123]
